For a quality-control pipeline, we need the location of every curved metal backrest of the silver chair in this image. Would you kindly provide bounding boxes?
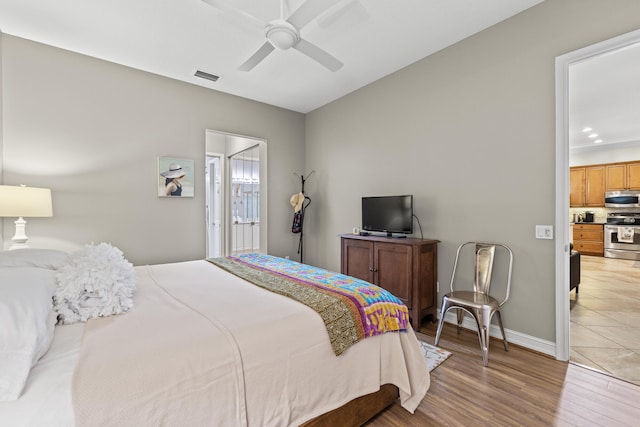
[450,242,513,305]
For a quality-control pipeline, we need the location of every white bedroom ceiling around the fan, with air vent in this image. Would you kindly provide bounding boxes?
[0,0,542,113]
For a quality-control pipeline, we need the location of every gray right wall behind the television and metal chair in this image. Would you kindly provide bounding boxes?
[305,0,640,341]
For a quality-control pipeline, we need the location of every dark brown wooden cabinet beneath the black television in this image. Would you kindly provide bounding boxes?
[340,234,439,331]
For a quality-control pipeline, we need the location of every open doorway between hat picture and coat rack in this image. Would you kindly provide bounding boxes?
[205,130,268,258]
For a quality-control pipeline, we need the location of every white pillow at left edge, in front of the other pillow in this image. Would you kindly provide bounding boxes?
[0,267,56,401]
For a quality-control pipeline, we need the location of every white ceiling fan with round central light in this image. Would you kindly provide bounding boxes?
[202,0,343,71]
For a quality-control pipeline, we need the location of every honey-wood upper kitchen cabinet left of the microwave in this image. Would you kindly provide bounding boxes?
[569,165,606,207]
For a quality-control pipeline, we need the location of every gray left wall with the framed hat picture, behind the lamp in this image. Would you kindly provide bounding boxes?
[1,34,304,264]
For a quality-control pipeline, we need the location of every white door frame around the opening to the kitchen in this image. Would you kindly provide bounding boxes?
[555,30,640,361]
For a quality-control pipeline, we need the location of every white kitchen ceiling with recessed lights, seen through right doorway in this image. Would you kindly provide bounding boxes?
[569,43,640,149]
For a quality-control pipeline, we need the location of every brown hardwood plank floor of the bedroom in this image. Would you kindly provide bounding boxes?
[366,323,640,427]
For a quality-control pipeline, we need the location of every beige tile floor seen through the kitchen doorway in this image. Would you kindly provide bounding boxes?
[570,255,640,384]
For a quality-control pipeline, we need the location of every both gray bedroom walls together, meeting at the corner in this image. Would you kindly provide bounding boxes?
[0,0,640,348]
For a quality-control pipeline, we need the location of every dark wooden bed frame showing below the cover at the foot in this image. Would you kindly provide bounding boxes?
[301,384,399,427]
